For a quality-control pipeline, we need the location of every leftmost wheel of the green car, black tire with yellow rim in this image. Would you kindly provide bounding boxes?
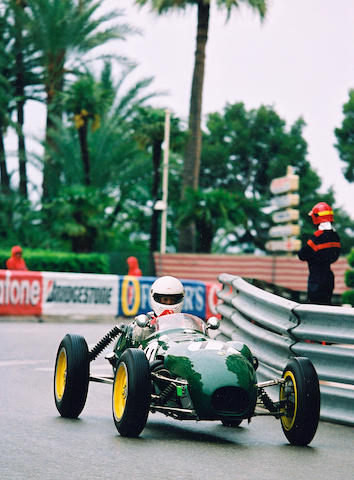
[54,333,90,418]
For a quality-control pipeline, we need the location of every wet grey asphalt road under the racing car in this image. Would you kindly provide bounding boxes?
[0,322,354,480]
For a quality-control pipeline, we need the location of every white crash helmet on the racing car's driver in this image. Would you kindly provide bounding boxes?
[150,275,184,316]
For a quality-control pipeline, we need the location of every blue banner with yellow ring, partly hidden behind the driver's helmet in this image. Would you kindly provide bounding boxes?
[118,275,206,318]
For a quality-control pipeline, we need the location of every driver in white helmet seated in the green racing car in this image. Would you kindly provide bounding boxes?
[133,275,184,342]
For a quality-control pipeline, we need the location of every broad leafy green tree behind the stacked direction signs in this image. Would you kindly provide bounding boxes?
[196,102,354,251]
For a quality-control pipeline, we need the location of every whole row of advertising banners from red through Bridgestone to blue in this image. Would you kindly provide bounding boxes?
[0,270,213,319]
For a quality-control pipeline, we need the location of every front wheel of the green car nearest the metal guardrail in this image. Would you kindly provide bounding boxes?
[279,357,320,445]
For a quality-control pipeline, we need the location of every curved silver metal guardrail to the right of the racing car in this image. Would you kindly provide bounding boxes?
[216,273,354,425]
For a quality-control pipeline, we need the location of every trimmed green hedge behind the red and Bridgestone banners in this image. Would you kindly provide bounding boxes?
[0,248,110,274]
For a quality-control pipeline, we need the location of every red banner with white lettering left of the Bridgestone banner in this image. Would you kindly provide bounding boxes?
[0,270,43,315]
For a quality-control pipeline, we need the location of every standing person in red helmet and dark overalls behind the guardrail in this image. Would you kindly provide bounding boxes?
[298,202,341,305]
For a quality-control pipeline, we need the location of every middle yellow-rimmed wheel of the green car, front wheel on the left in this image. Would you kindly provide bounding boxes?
[112,348,151,437]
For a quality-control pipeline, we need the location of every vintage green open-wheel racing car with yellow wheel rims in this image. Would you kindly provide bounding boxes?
[54,313,320,445]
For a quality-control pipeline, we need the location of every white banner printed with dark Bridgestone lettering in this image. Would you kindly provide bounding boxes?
[42,272,119,315]
